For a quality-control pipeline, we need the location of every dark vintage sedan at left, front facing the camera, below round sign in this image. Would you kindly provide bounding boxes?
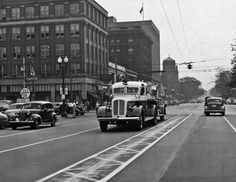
[9,101,57,130]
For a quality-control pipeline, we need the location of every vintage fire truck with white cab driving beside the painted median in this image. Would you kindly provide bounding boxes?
[97,81,166,132]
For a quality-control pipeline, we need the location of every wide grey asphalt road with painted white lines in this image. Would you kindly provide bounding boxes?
[0,104,236,182]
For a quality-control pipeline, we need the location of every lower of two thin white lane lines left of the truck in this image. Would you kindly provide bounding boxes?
[0,127,98,154]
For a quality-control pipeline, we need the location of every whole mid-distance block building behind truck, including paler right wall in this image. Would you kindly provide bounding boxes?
[108,17,161,82]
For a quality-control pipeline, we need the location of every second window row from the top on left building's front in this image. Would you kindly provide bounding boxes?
[0,23,80,41]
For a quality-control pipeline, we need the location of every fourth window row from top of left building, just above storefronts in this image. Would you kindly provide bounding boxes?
[0,63,106,78]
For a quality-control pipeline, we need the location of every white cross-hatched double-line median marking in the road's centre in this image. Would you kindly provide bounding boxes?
[37,115,191,182]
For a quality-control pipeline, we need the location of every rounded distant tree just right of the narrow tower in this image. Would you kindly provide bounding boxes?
[179,77,206,101]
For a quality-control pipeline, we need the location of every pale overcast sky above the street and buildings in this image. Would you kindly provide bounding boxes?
[96,0,236,89]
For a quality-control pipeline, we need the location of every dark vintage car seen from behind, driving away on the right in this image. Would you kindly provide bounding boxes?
[204,97,225,116]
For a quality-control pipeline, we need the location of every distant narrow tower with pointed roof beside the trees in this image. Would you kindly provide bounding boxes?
[162,57,179,96]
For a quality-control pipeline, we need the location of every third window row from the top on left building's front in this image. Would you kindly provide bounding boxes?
[0,43,80,60]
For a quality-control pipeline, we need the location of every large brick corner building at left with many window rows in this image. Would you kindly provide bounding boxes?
[0,0,108,104]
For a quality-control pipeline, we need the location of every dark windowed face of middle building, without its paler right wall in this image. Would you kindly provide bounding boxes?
[108,17,153,81]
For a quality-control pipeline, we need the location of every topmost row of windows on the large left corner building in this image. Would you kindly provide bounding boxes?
[0,2,107,28]
